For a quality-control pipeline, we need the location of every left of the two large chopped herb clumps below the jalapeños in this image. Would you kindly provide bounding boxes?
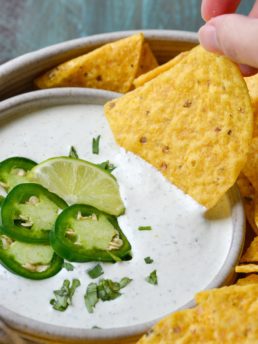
[50,279,81,312]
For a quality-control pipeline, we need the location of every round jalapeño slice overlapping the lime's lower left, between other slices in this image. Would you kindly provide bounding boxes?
[1,183,67,244]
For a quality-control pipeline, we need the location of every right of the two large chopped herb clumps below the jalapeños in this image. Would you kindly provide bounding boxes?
[84,277,132,313]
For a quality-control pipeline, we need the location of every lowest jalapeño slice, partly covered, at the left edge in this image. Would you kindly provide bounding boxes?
[0,227,63,280]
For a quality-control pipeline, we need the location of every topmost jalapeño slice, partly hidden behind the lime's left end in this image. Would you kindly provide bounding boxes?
[0,157,37,191]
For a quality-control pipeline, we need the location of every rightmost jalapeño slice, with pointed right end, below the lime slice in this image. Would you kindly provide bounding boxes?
[50,204,132,262]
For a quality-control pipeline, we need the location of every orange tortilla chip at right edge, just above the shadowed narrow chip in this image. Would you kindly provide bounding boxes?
[243,137,258,192]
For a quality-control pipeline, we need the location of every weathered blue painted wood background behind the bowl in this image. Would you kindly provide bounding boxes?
[0,0,254,63]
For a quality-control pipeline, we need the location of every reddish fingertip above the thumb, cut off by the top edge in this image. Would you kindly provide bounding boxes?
[201,0,241,21]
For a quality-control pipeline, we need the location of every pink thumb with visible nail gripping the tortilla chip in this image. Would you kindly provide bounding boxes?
[199,14,258,68]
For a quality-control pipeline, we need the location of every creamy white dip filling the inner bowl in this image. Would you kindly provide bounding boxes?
[0,105,233,328]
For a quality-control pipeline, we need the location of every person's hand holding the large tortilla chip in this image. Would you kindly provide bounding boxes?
[199,0,258,75]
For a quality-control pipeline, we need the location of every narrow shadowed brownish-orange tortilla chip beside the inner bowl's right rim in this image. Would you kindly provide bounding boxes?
[237,173,258,234]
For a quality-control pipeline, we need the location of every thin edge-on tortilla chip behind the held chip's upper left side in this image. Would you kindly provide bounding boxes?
[133,51,188,88]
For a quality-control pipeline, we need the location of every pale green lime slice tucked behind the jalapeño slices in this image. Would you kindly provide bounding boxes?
[28,157,125,216]
